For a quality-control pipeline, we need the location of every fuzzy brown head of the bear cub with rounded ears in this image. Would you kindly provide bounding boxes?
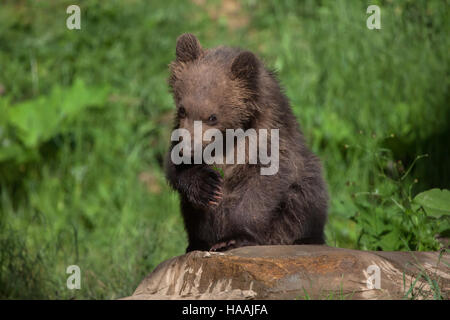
[169,33,263,145]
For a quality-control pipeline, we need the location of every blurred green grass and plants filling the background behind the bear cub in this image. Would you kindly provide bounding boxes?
[0,0,450,299]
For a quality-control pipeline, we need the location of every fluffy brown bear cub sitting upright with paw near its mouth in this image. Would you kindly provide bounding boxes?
[166,34,328,252]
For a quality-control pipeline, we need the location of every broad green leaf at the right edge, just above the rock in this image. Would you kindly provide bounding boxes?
[413,188,450,218]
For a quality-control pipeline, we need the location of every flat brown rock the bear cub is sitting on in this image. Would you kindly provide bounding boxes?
[125,245,450,299]
